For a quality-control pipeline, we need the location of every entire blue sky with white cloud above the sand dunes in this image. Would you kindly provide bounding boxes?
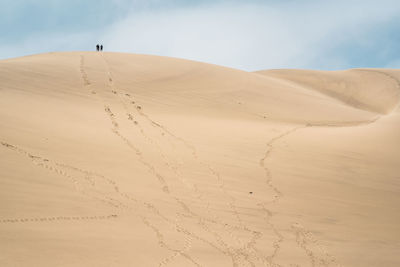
[0,0,400,71]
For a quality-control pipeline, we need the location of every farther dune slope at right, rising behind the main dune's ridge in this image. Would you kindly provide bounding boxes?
[256,69,400,114]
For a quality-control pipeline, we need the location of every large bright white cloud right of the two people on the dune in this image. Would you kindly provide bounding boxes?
[103,1,400,70]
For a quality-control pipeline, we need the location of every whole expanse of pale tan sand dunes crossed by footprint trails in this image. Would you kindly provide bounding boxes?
[0,52,400,267]
